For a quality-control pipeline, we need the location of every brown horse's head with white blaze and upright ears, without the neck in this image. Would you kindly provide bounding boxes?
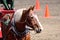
[26,6,43,33]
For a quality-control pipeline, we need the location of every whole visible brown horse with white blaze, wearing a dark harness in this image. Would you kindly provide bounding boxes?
[2,6,43,40]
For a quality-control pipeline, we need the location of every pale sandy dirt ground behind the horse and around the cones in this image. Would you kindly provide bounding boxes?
[0,0,60,40]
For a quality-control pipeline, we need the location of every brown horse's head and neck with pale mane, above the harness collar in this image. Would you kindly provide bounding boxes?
[14,6,43,33]
